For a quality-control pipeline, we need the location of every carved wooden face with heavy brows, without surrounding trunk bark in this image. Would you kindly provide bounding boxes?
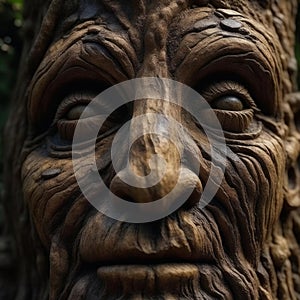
[18,0,298,300]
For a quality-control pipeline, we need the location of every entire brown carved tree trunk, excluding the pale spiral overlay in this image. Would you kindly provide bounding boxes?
[0,0,300,300]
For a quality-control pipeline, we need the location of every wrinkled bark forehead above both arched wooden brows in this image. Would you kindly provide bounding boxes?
[24,0,297,77]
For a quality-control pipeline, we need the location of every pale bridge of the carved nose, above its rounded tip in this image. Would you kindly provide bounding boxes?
[130,99,183,185]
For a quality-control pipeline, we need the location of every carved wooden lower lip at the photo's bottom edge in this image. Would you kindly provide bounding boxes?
[68,263,204,300]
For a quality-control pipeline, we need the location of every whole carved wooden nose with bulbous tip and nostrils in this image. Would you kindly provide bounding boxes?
[110,96,202,206]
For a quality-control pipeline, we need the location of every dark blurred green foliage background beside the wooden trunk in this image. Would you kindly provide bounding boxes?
[0,0,300,198]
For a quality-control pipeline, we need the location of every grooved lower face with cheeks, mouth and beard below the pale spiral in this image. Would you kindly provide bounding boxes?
[23,125,284,300]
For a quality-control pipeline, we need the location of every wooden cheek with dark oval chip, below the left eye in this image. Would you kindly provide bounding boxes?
[22,149,78,247]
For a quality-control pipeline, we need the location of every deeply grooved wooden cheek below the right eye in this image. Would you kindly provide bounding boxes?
[239,134,286,240]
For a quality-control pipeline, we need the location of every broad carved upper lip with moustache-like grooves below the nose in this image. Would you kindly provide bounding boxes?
[80,213,214,270]
